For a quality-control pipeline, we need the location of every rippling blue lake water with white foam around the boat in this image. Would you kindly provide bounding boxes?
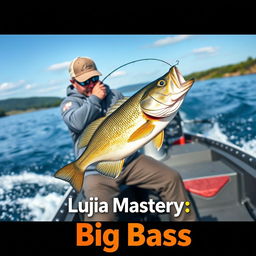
[0,75,256,221]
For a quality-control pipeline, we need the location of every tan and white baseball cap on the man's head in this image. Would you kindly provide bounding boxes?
[69,57,102,82]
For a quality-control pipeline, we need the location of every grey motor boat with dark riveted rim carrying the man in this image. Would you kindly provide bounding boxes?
[52,113,256,222]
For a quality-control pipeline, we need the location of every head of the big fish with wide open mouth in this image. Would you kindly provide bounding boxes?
[140,66,194,118]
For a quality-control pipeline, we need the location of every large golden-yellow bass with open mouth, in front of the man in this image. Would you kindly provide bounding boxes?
[55,66,194,192]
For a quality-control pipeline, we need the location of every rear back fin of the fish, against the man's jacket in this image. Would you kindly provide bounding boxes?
[77,116,106,149]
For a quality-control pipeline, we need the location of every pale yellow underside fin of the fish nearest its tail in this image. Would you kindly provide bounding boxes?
[96,159,124,178]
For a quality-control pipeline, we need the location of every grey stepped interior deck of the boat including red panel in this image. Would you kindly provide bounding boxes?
[164,143,252,221]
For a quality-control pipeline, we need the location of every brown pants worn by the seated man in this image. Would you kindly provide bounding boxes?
[83,155,196,221]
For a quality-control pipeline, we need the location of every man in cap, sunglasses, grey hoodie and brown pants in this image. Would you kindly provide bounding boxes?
[60,57,196,221]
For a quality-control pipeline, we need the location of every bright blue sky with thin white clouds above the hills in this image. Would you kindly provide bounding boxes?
[0,34,256,100]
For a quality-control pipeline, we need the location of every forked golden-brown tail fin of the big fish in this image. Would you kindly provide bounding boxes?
[54,162,84,192]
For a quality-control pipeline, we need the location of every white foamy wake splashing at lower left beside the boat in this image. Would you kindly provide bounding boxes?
[0,172,69,221]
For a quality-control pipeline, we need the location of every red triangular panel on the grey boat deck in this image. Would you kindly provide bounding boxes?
[184,176,230,197]
